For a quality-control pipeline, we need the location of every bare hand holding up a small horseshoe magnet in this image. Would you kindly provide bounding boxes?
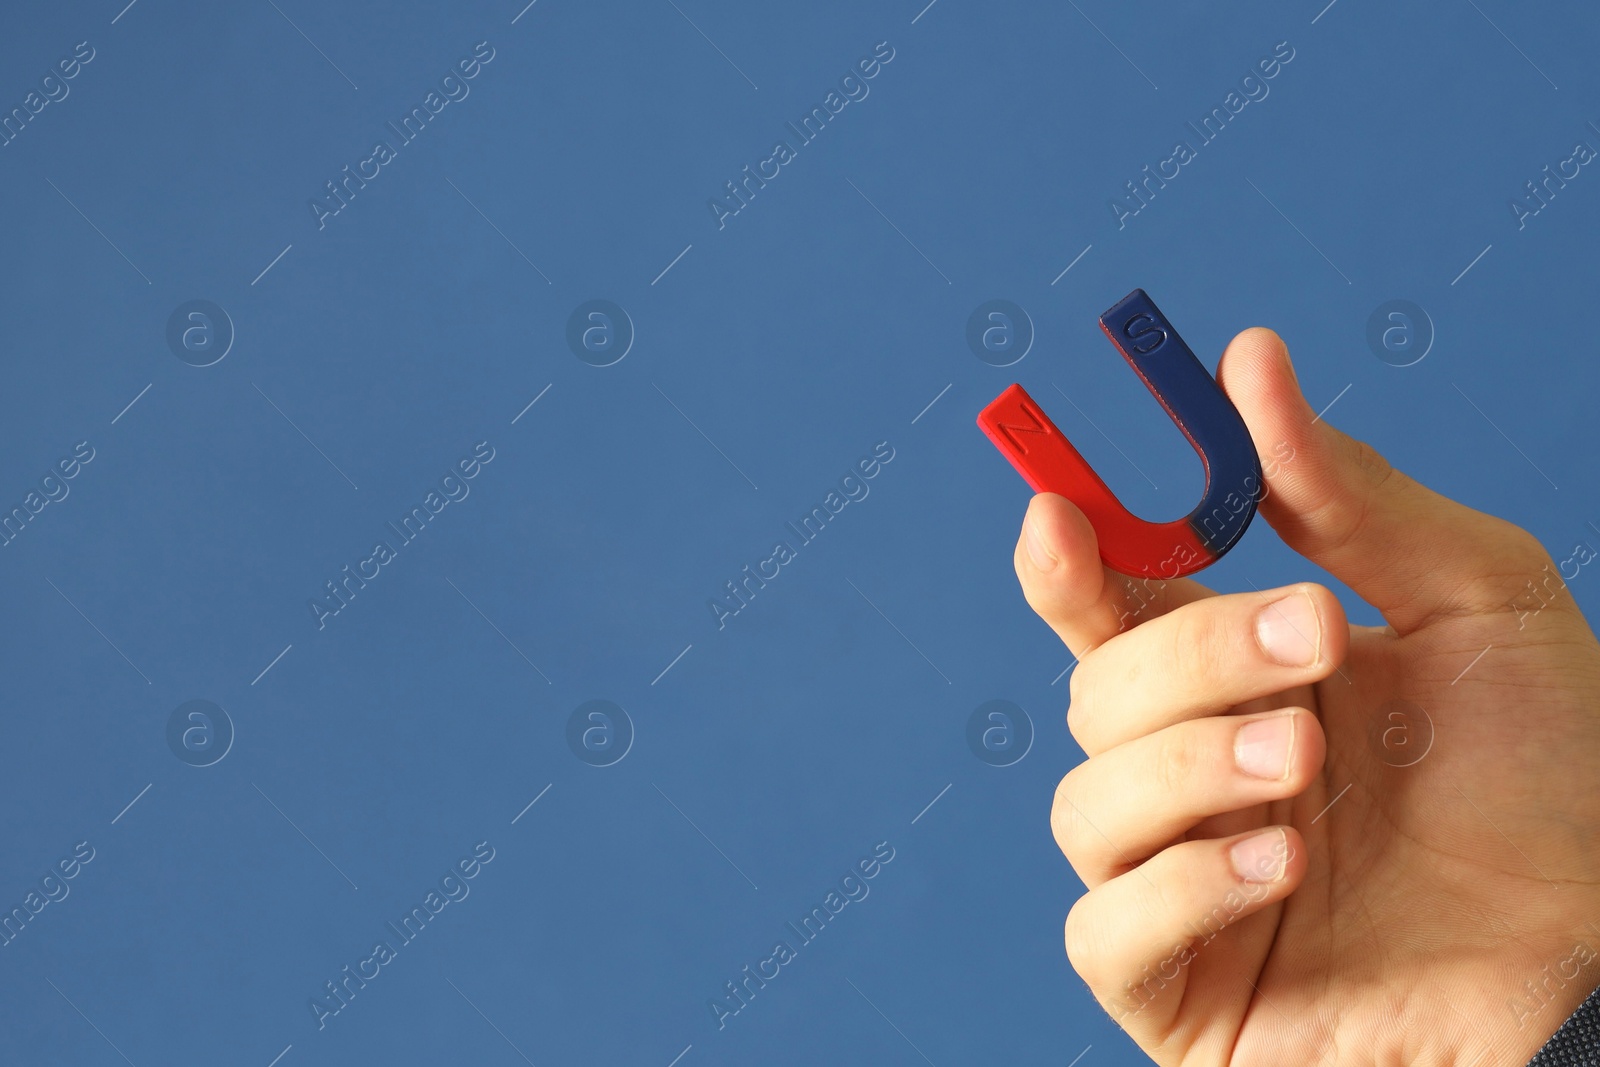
[1016,330,1600,1067]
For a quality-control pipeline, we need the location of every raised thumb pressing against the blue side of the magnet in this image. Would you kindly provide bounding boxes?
[1218,326,1549,635]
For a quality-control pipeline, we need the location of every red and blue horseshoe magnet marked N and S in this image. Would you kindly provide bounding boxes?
[978,290,1264,579]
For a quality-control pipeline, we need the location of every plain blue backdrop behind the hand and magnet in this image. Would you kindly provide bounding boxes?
[0,0,1600,1067]
